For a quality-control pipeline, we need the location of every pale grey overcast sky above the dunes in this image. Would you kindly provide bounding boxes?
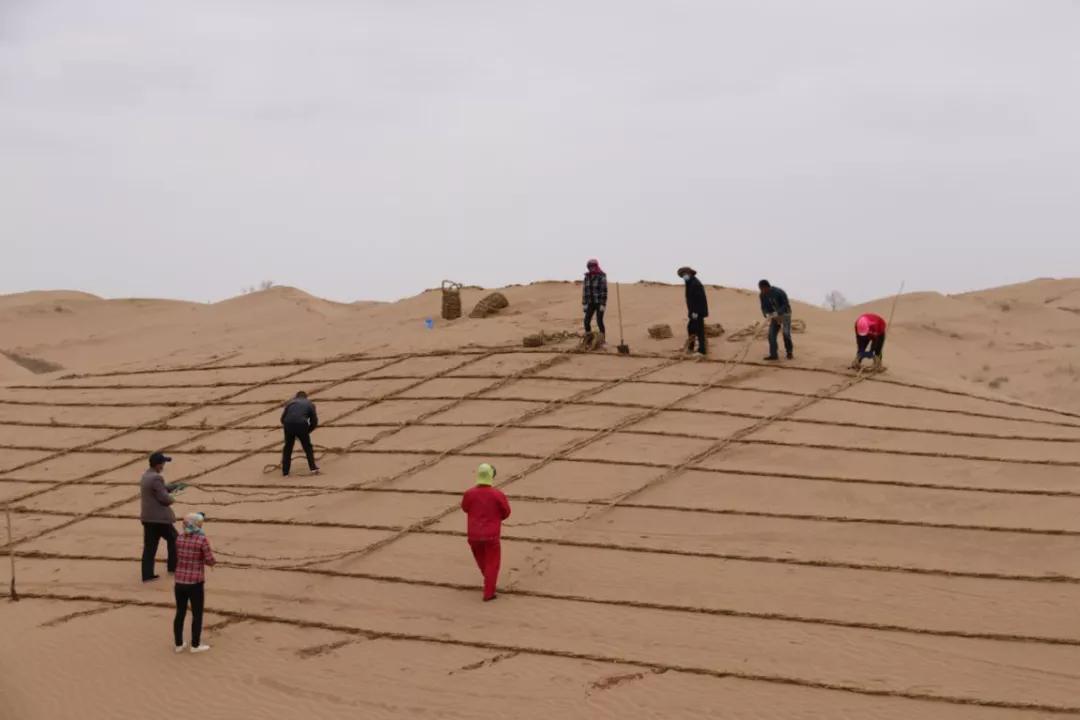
[0,0,1080,302]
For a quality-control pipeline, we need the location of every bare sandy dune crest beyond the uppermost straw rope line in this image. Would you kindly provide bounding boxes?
[0,280,1080,408]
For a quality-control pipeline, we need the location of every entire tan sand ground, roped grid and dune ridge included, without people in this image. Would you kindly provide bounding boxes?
[0,279,1080,720]
